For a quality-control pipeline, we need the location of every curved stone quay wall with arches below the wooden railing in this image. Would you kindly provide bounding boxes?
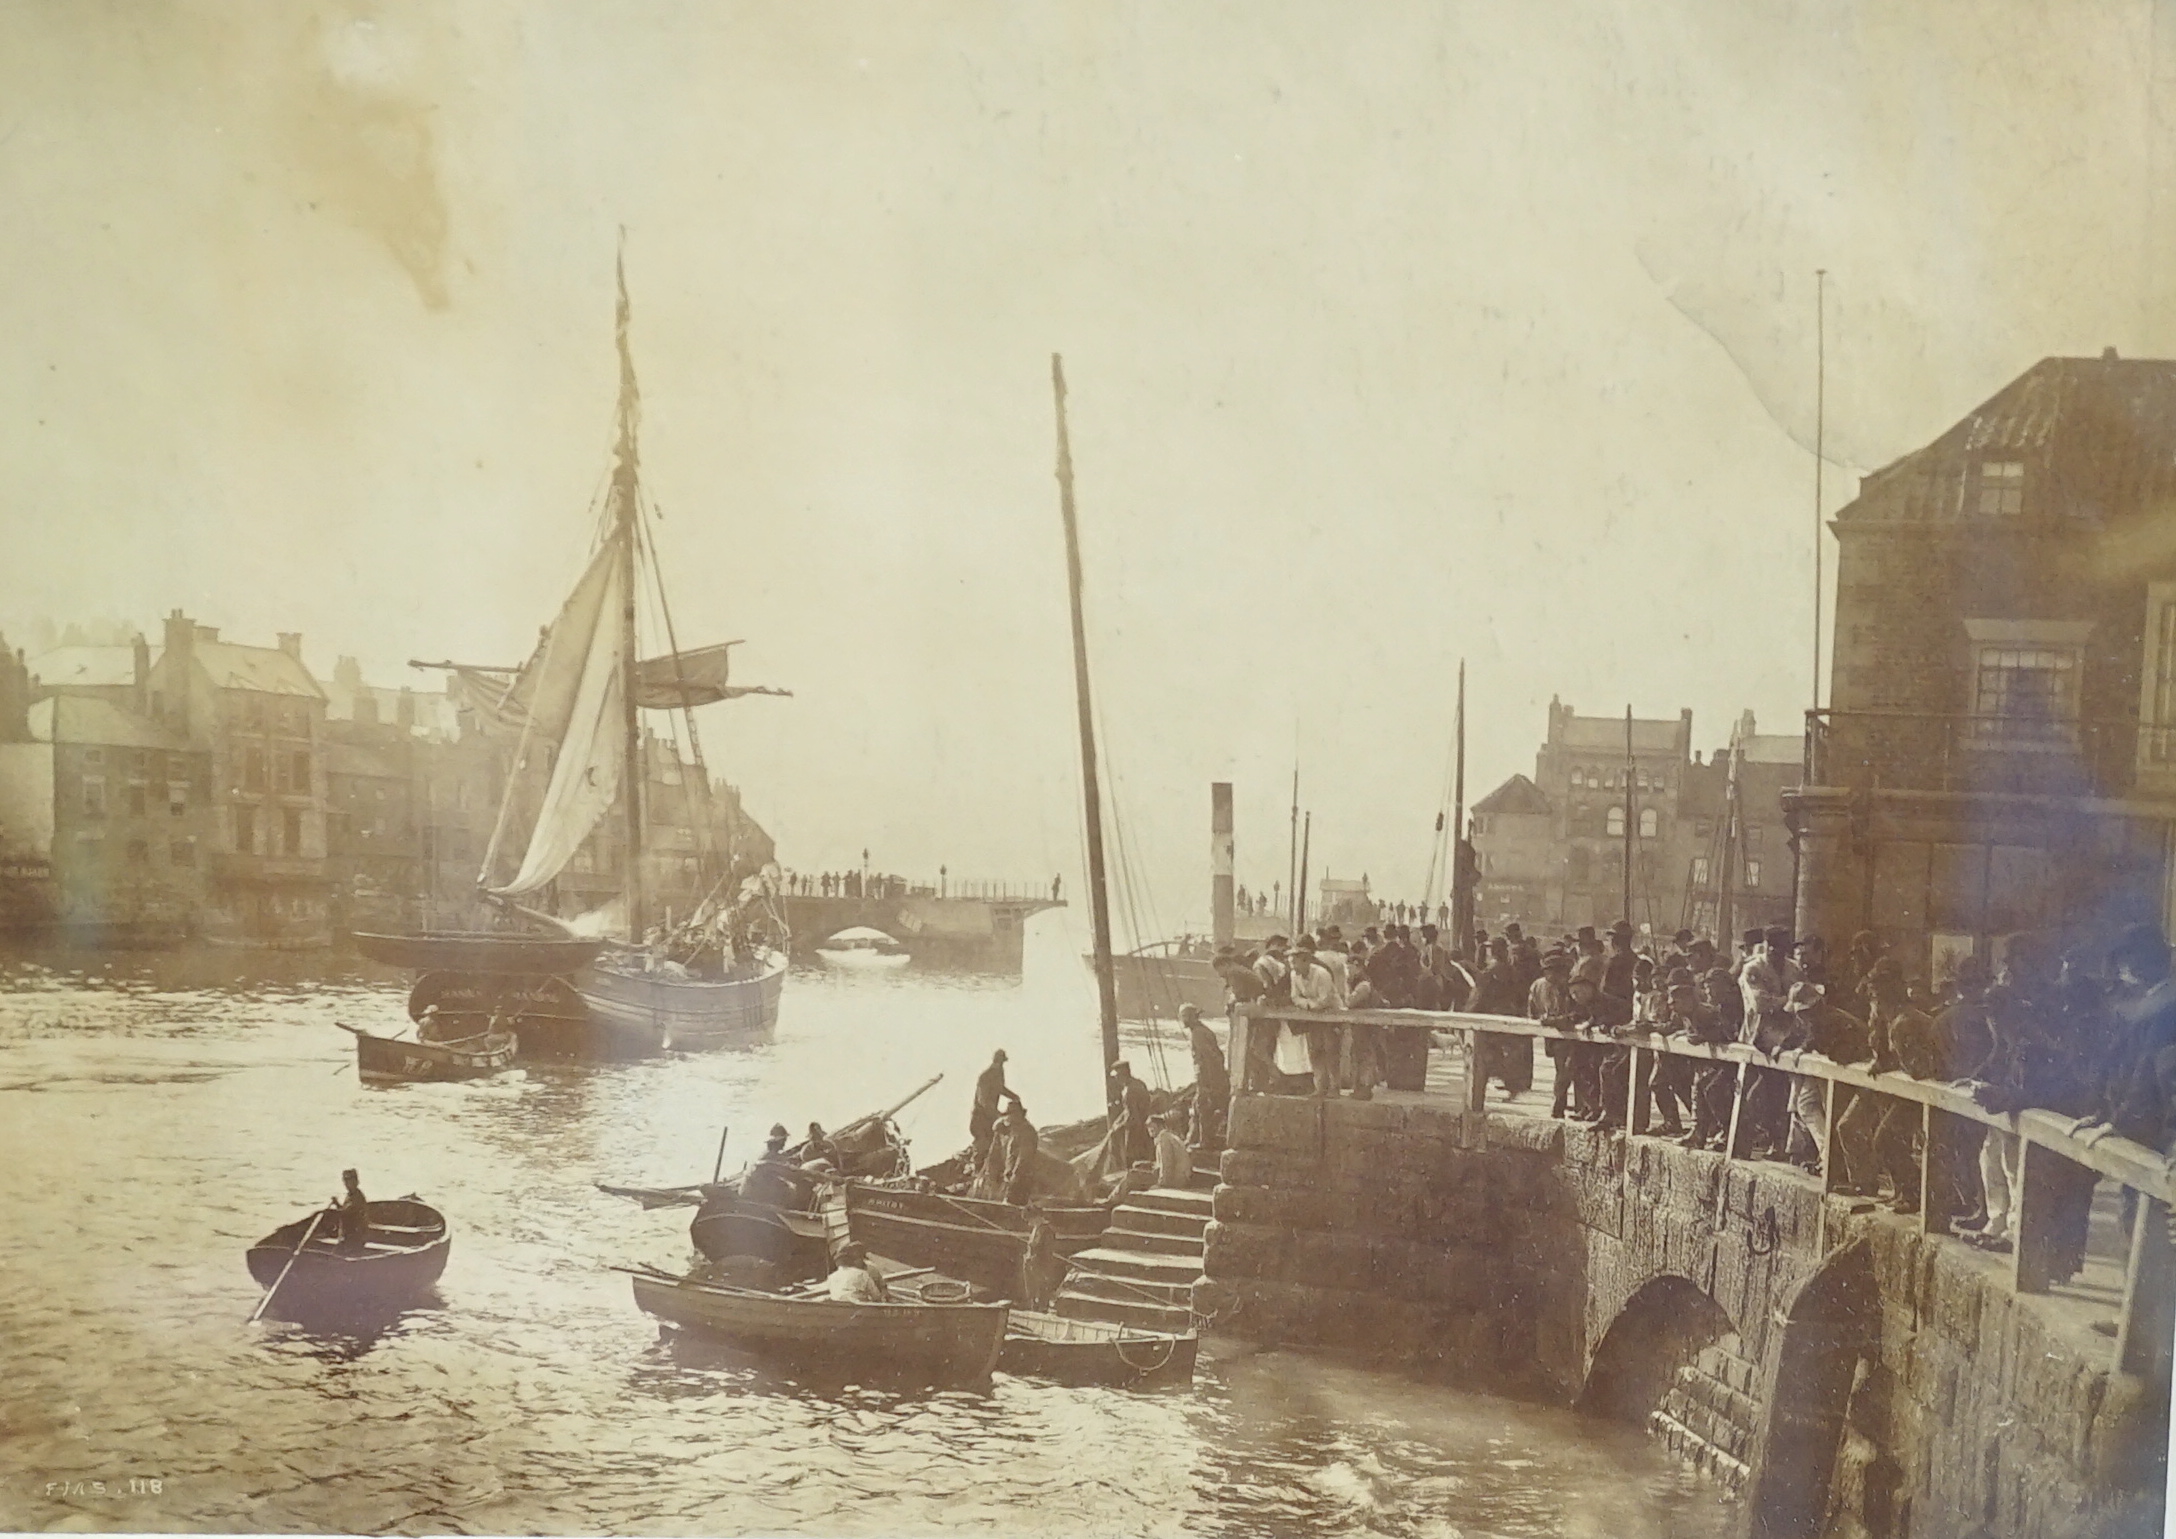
[1199,1012,2172,1539]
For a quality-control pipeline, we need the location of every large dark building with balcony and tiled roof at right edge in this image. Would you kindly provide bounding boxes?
[1793,350,2176,975]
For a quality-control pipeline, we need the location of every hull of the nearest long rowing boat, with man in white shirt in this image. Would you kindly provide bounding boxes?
[633,1271,1007,1382]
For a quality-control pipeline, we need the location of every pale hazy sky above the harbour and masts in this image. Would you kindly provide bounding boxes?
[0,0,2176,919]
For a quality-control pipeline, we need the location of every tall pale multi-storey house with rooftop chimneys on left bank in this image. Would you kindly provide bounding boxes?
[146,610,331,947]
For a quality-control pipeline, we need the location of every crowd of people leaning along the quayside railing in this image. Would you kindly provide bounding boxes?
[1216,921,2176,1269]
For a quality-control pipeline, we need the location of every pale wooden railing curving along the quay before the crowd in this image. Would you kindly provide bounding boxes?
[1229,1006,2176,1374]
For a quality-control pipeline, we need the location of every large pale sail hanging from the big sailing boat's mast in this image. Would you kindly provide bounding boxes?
[485,542,627,897]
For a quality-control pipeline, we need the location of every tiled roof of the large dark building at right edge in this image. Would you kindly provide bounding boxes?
[1837,357,2176,522]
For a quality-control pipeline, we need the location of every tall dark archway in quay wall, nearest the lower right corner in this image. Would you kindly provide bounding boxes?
[1747,1241,1887,1539]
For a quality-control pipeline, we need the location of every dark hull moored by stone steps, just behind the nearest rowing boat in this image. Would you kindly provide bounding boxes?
[823,1182,1110,1297]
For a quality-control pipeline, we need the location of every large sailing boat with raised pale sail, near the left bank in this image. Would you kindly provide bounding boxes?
[357,247,788,1051]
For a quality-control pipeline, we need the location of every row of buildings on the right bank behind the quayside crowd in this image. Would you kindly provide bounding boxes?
[1473,350,2176,977]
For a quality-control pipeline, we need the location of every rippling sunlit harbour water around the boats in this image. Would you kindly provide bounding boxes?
[0,914,1736,1539]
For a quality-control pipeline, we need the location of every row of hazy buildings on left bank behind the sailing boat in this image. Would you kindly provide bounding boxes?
[0,610,772,947]
